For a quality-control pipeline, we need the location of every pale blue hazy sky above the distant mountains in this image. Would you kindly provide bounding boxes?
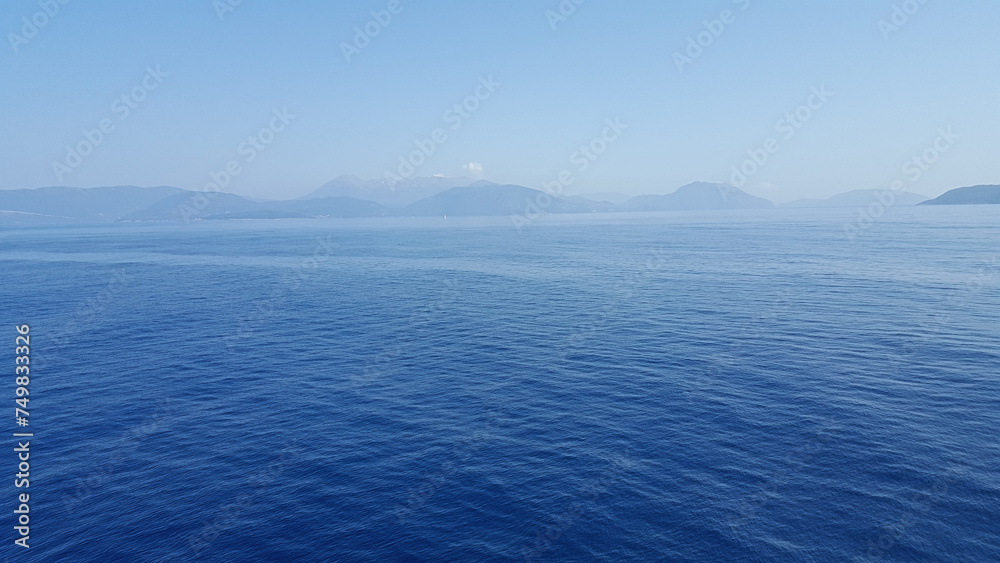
[0,0,1000,202]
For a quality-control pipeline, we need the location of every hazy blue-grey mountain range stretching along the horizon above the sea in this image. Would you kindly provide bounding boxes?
[0,180,1000,225]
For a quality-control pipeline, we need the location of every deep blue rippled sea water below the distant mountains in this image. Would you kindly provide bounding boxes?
[0,206,1000,562]
